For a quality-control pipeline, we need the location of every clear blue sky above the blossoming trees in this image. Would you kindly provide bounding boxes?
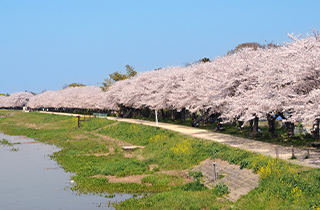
[0,0,320,94]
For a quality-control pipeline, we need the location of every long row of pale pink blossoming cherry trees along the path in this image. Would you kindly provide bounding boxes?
[0,31,320,136]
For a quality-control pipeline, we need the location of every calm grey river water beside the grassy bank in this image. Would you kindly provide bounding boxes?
[0,133,132,210]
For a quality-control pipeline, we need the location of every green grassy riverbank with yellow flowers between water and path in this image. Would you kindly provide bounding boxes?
[0,111,320,209]
